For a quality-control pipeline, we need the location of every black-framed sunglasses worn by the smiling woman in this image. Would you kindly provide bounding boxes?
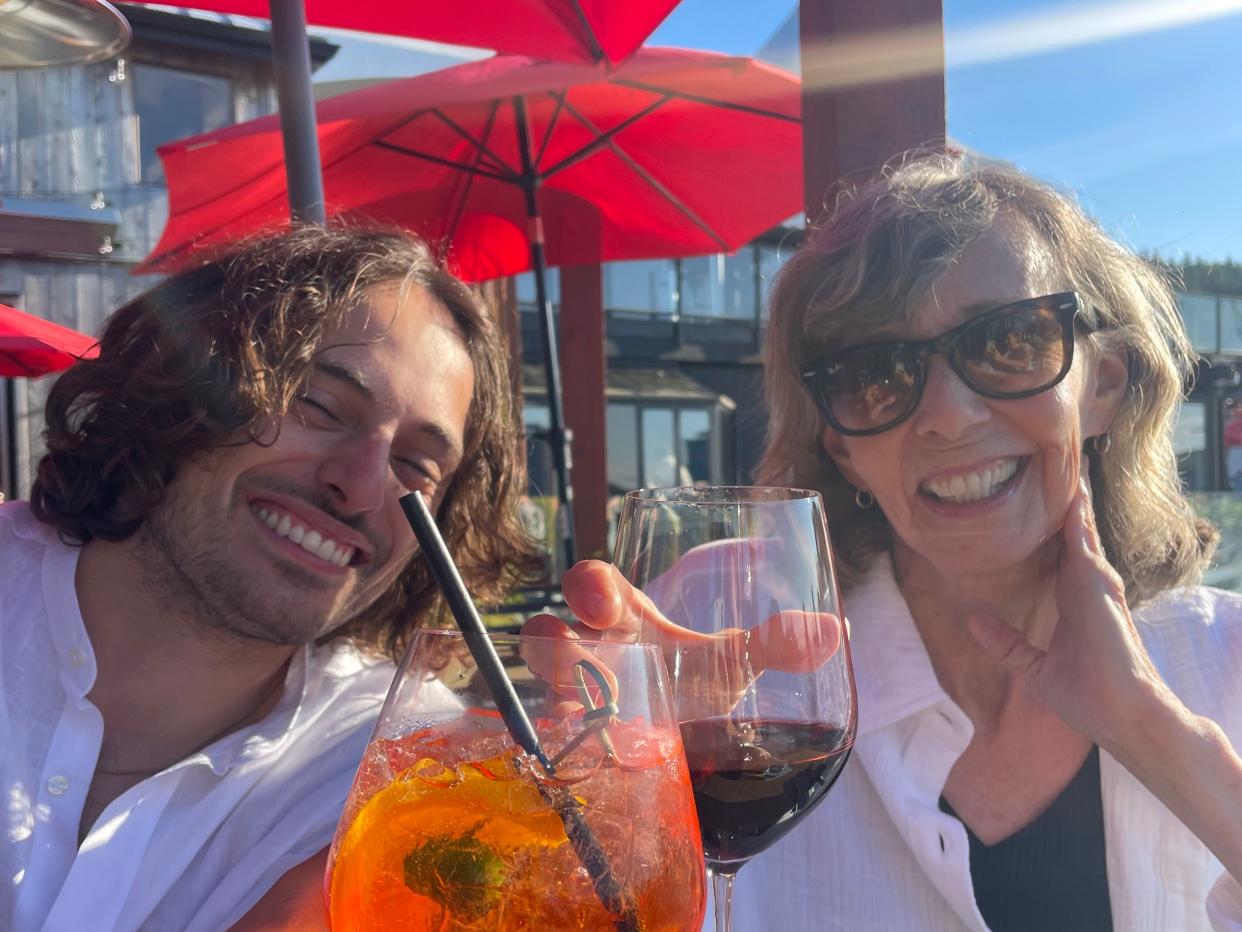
[802,292,1078,437]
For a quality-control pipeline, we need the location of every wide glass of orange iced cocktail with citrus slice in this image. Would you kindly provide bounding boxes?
[325,630,707,932]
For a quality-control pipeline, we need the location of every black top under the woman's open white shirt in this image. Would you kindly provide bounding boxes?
[940,747,1113,932]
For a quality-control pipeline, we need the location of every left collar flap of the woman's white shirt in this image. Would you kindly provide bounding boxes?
[845,553,948,734]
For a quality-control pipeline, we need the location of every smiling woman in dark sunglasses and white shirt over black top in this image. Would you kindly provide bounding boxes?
[551,149,1242,932]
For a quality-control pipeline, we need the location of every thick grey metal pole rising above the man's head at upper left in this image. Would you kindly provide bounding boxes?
[270,0,327,224]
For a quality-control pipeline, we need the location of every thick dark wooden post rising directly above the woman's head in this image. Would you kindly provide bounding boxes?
[799,0,945,222]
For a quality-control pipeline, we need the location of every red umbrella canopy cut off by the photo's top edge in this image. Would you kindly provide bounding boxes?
[126,0,678,65]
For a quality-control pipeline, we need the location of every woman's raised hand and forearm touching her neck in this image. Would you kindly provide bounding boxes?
[968,481,1242,880]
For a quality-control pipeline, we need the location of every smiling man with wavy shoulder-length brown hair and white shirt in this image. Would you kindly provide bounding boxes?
[0,227,543,932]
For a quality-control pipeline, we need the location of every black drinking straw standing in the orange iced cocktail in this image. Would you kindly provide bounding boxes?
[401,492,642,932]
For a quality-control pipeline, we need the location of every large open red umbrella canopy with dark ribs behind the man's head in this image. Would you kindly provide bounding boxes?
[140,48,802,280]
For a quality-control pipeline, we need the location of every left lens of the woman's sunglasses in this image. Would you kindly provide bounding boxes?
[821,347,919,431]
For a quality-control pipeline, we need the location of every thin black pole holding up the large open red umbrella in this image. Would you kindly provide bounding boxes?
[513,96,576,569]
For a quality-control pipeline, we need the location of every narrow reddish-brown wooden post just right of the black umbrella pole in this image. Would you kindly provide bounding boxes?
[560,265,609,559]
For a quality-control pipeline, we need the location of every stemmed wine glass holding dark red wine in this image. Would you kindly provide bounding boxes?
[614,487,857,932]
